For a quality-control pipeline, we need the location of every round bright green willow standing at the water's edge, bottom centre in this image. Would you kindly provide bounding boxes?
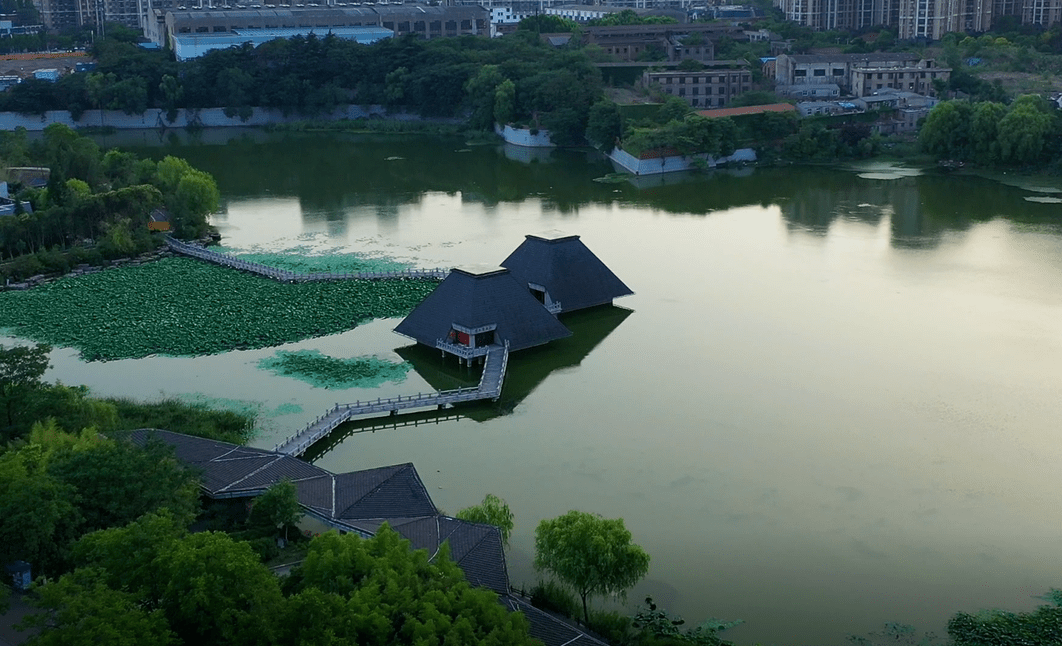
[534,510,649,623]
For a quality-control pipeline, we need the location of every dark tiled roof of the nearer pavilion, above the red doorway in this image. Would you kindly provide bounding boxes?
[395,268,571,351]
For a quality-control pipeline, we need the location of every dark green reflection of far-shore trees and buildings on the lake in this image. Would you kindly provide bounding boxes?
[114,131,1062,248]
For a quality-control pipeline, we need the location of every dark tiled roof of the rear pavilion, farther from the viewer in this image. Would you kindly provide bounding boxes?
[501,232,634,311]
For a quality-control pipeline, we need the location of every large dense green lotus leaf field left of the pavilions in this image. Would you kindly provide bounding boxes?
[0,258,436,361]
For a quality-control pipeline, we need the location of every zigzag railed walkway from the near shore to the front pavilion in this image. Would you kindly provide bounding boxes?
[273,343,509,457]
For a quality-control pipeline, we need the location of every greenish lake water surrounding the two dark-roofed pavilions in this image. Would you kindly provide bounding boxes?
[14,132,1062,646]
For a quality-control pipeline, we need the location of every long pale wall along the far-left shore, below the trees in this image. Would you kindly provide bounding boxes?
[0,105,435,131]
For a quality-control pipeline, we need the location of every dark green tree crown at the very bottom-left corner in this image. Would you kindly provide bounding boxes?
[21,570,178,646]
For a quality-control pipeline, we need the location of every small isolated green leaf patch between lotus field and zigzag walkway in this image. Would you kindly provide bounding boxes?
[258,350,410,390]
